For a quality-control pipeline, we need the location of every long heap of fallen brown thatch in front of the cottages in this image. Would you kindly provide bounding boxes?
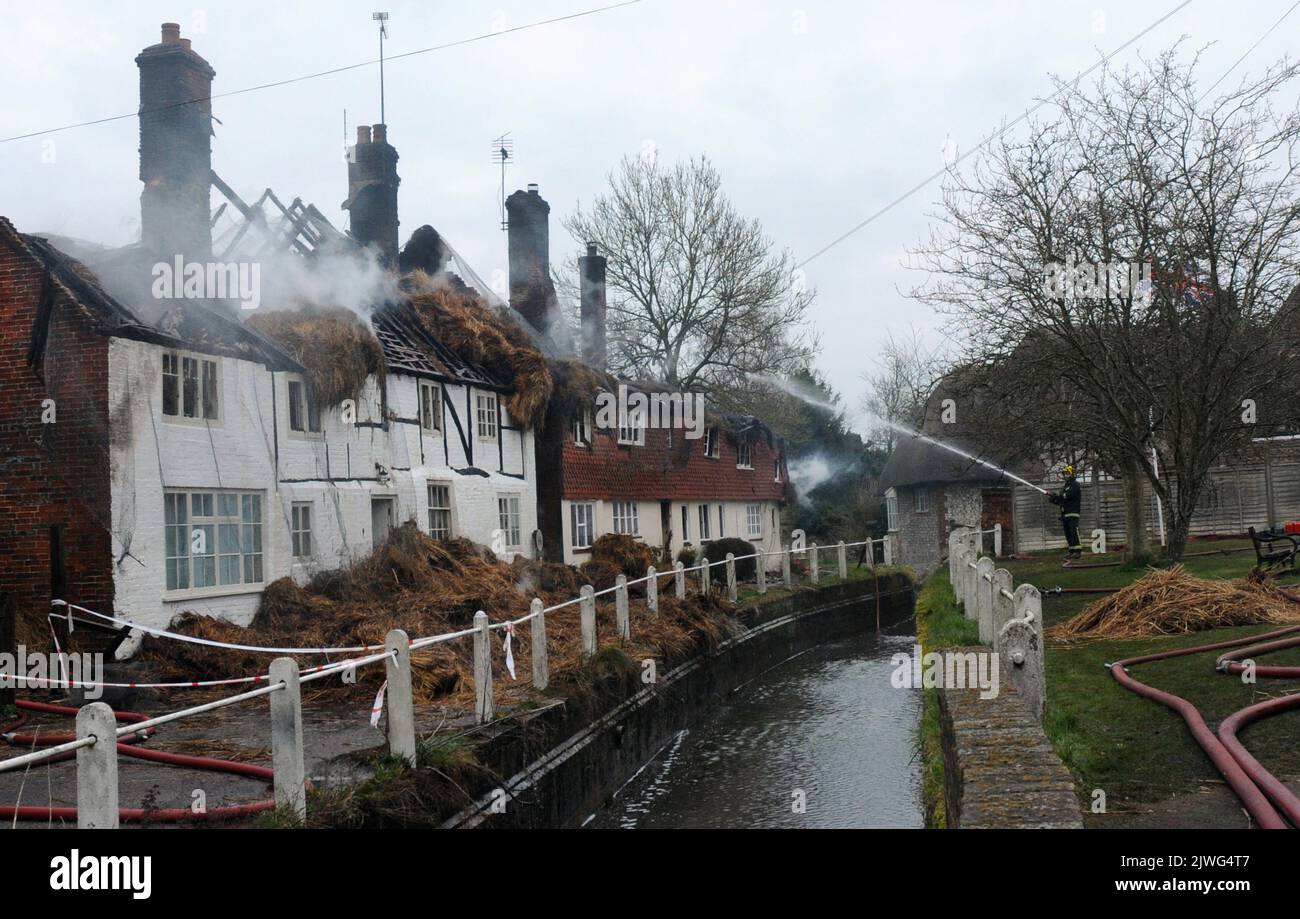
[140,524,738,707]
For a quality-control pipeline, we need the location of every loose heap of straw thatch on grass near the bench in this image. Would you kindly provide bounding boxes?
[1047,565,1300,641]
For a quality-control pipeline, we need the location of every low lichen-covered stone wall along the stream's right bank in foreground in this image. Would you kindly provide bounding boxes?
[939,647,1083,829]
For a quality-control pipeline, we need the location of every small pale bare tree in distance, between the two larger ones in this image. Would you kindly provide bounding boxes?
[862,326,950,454]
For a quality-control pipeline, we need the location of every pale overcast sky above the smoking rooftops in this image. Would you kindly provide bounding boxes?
[0,0,1300,426]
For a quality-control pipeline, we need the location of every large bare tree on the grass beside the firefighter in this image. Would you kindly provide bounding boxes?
[917,48,1300,559]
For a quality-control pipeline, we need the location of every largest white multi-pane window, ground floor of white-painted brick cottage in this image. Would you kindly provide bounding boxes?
[163,489,267,599]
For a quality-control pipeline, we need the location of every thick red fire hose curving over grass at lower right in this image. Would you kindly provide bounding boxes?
[1108,610,1300,829]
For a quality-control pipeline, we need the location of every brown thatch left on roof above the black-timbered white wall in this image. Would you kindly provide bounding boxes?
[402,272,555,428]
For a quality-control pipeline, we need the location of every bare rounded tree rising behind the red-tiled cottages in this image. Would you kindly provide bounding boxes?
[564,157,815,391]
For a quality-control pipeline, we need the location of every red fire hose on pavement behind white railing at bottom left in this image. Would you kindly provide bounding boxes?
[0,701,276,823]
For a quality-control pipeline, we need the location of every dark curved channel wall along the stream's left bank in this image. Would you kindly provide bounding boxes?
[443,575,915,828]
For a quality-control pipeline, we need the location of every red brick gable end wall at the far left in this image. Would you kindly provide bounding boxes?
[0,226,113,630]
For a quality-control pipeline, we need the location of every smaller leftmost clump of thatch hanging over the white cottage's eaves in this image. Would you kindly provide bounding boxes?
[248,308,385,408]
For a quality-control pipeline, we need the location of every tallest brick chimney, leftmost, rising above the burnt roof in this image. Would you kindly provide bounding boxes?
[135,22,217,260]
